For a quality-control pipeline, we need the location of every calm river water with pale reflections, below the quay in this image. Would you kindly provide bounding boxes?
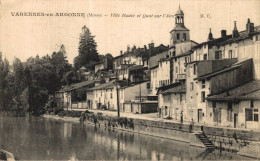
[0,116,255,160]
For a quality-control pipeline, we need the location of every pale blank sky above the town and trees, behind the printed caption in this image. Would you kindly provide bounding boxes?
[0,0,260,63]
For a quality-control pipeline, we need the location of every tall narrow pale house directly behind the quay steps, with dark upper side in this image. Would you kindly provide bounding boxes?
[184,59,237,123]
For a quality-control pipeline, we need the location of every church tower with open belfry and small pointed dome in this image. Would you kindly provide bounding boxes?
[170,6,190,46]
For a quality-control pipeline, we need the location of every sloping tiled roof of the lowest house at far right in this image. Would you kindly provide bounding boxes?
[207,80,260,101]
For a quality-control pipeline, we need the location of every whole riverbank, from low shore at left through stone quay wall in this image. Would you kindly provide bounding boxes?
[44,110,260,158]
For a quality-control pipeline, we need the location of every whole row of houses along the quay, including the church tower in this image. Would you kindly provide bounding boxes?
[54,8,260,129]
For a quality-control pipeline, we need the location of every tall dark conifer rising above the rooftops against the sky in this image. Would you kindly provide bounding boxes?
[74,26,99,69]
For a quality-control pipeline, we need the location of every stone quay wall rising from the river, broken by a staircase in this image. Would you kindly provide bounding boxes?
[87,116,260,158]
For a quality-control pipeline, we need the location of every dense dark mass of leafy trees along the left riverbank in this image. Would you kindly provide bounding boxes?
[0,45,73,115]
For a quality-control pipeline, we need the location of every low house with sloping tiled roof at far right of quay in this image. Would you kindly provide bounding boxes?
[207,80,260,130]
